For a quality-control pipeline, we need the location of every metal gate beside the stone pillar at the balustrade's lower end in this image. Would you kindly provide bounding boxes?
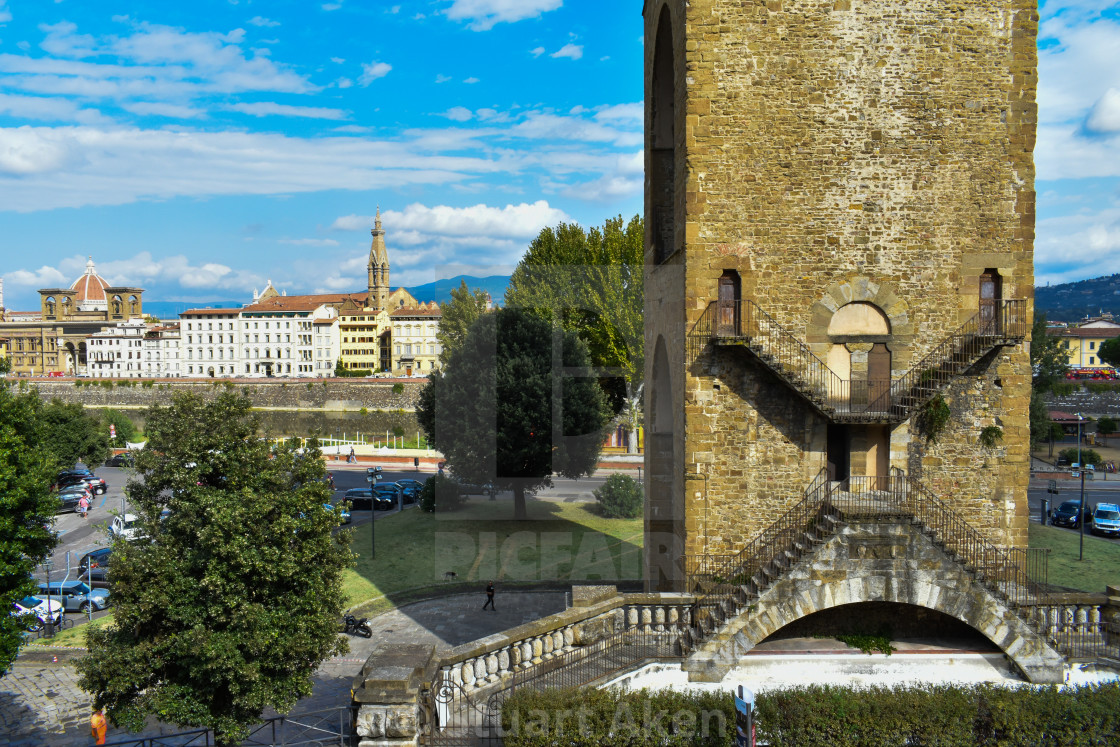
[420,674,506,747]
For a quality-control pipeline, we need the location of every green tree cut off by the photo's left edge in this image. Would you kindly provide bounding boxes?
[0,387,58,673]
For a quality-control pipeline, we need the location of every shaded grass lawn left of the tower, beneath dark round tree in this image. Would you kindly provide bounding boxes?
[345,498,642,611]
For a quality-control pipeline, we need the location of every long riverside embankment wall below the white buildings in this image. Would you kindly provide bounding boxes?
[17,379,427,412]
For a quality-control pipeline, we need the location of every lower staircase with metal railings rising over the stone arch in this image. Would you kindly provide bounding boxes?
[684,470,1048,651]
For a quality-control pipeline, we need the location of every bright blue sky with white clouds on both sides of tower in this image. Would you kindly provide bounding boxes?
[0,0,1120,309]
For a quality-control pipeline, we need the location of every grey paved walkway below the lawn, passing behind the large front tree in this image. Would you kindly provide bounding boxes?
[0,585,564,747]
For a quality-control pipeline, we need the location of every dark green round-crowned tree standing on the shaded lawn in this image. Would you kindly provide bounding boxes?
[417,309,608,519]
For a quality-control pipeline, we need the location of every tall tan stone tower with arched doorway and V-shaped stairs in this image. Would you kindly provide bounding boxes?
[644,0,1038,590]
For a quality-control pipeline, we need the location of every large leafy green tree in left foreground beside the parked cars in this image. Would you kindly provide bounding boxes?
[77,393,352,745]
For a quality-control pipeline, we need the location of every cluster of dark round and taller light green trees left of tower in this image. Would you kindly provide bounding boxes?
[417,216,644,519]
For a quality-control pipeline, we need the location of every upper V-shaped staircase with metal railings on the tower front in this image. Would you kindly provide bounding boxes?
[689,299,1029,421]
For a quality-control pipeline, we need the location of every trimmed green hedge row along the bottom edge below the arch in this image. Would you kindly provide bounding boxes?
[502,683,1120,747]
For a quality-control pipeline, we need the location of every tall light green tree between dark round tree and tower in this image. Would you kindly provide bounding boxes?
[505,215,645,412]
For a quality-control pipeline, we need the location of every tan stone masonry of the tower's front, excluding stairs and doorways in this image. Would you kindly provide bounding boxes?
[645,0,1037,564]
